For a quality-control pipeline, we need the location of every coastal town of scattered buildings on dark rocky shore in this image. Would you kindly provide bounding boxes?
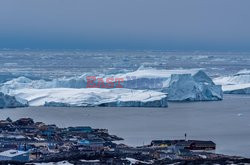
[0,118,250,165]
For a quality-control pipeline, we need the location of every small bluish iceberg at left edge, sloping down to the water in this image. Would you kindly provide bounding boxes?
[0,92,28,108]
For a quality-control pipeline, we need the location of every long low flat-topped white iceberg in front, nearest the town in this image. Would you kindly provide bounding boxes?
[12,88,168,107]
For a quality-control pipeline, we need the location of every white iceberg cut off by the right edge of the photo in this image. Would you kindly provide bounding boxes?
[214,69,250,94]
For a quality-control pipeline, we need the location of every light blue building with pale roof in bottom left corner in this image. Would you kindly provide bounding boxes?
[0,149,29,162]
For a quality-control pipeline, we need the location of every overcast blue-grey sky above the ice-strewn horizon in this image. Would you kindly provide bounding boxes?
[0,0,250,51]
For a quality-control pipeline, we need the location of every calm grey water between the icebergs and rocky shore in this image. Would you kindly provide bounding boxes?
[0,95,250,157]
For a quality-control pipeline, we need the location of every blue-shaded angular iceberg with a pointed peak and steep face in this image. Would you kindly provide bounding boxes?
[164,70,223,101]
